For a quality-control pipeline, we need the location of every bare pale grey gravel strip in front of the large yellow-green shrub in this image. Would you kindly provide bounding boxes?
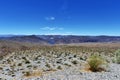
[12,64,120,80]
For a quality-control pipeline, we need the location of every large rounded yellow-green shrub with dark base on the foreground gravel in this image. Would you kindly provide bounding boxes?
[87,55,107,72]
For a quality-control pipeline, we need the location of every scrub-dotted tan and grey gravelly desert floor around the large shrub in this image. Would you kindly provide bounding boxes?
[0,43,120,80]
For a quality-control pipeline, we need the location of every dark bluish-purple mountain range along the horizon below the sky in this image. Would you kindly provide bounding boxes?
[0,35,120,44]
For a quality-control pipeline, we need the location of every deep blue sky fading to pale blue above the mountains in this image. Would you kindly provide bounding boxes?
[0,0,120,35]
